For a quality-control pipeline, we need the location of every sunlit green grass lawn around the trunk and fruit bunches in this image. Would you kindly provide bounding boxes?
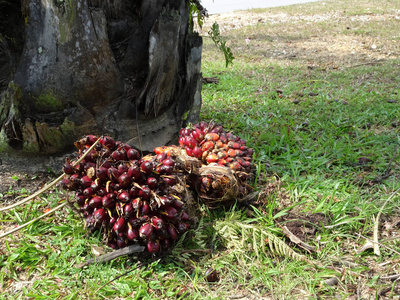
[0,0,400,299]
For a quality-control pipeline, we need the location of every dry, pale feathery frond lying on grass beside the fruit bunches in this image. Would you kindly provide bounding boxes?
[214,219,310,263]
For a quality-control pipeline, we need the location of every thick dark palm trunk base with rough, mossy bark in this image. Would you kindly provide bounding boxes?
[0,0,202,155]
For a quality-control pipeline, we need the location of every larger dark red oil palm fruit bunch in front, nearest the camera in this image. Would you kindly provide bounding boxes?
[61,135,195,253]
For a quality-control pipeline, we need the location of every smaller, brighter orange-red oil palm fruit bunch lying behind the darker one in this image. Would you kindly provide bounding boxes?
[179,121,254,206]
